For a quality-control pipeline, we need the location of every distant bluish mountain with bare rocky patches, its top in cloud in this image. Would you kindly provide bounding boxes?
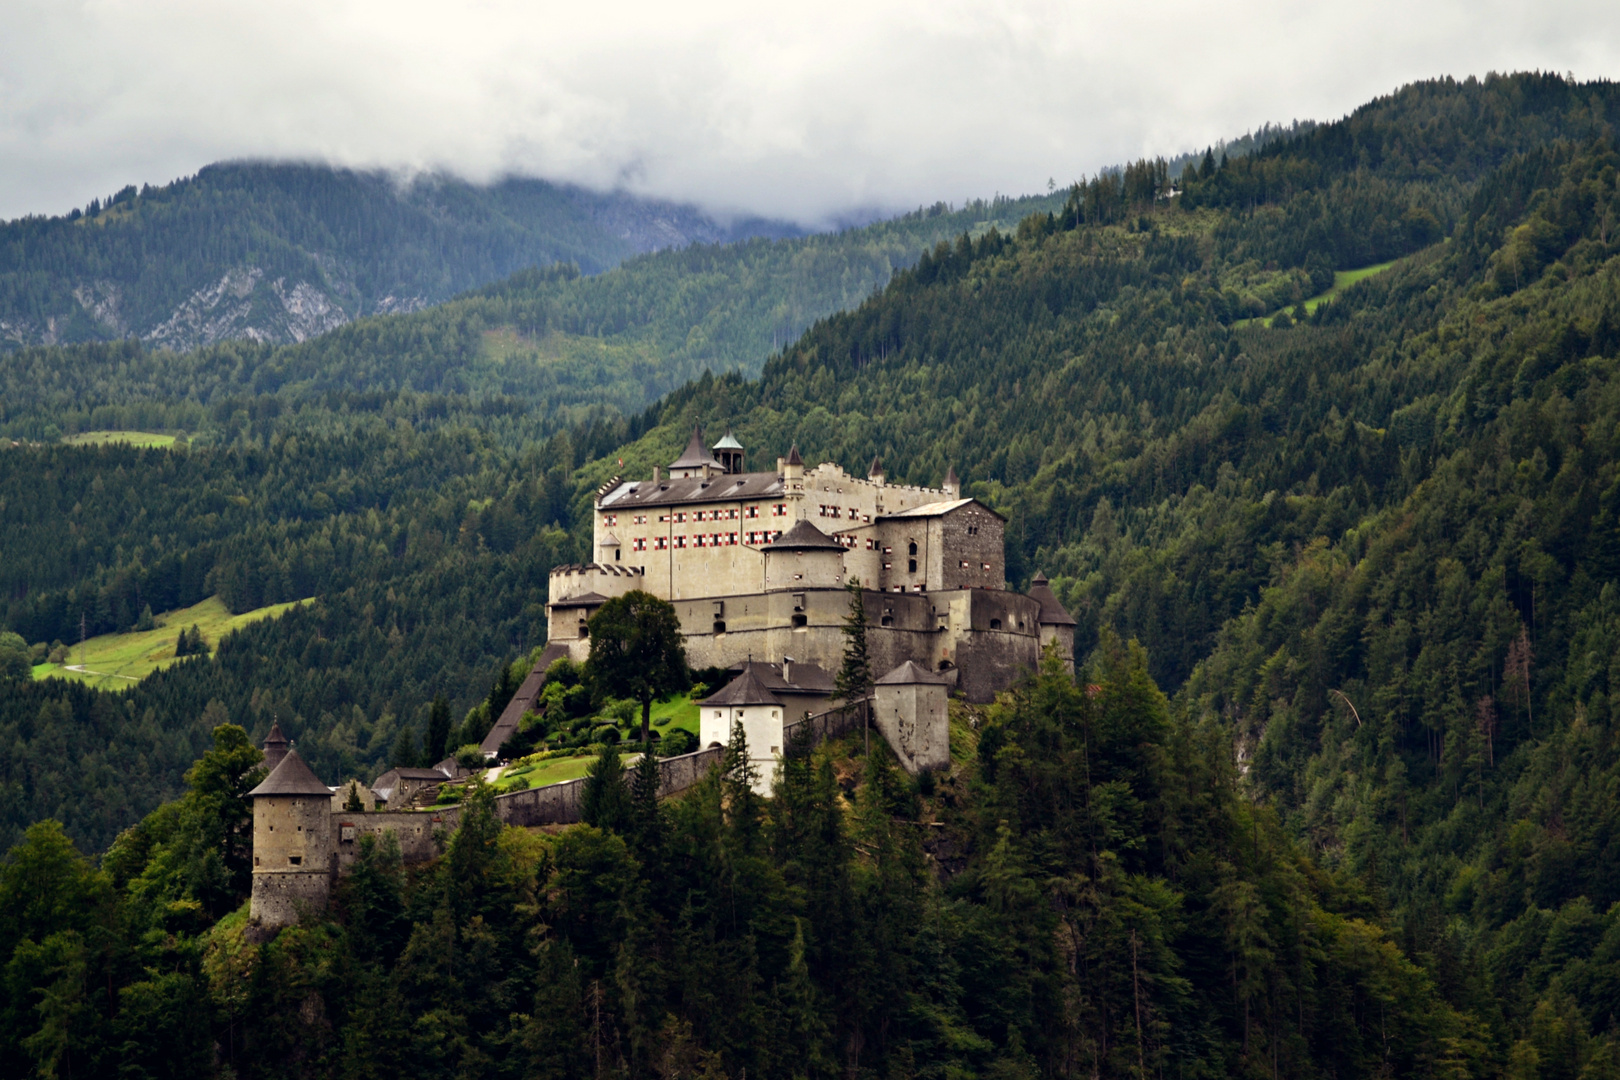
[0,162,804,350]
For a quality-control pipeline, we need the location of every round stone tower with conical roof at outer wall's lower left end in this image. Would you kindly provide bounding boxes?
[248,740,335,926]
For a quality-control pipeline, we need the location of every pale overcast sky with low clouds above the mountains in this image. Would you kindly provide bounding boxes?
[0,0,1620,222]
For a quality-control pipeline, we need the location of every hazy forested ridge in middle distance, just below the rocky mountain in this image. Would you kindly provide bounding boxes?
[0,198,1061,450]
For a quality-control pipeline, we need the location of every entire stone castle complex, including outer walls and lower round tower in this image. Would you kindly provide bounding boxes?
[249,431,1076,926]
